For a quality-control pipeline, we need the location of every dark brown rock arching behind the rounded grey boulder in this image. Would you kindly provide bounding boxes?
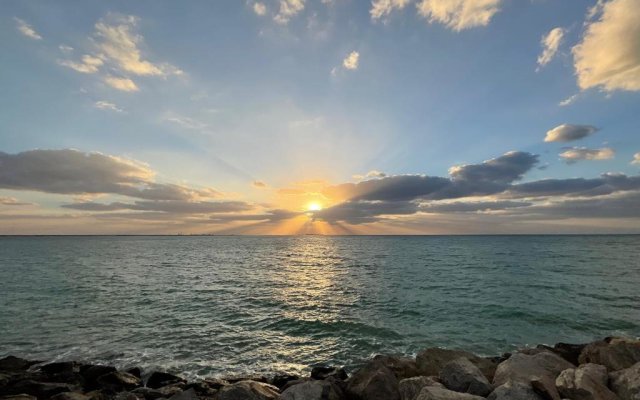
[416,347,498,381]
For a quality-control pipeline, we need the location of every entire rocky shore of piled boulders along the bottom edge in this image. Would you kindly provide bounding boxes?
[0,338,640,400]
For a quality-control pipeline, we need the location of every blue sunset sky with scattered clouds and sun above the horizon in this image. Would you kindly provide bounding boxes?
[0,0,640,235]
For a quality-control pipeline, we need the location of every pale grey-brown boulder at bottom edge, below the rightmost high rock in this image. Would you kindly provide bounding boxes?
[556,364,618,400]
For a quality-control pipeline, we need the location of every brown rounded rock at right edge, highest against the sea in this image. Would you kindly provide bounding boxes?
[578,338,640,371]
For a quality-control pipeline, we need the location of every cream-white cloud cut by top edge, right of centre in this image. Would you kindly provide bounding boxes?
[417,0,502,31]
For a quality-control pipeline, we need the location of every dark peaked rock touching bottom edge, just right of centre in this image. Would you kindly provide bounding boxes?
[346,362,400,400]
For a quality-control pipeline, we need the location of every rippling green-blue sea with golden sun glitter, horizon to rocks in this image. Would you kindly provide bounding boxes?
[0,236,640,378]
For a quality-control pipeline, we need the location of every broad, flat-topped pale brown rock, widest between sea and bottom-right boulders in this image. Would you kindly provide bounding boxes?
[493,351,574,387]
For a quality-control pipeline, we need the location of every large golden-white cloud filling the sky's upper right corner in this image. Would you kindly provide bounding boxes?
[573,0,640,91]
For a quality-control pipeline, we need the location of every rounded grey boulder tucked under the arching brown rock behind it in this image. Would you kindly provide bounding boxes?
[440,357,493,397]
